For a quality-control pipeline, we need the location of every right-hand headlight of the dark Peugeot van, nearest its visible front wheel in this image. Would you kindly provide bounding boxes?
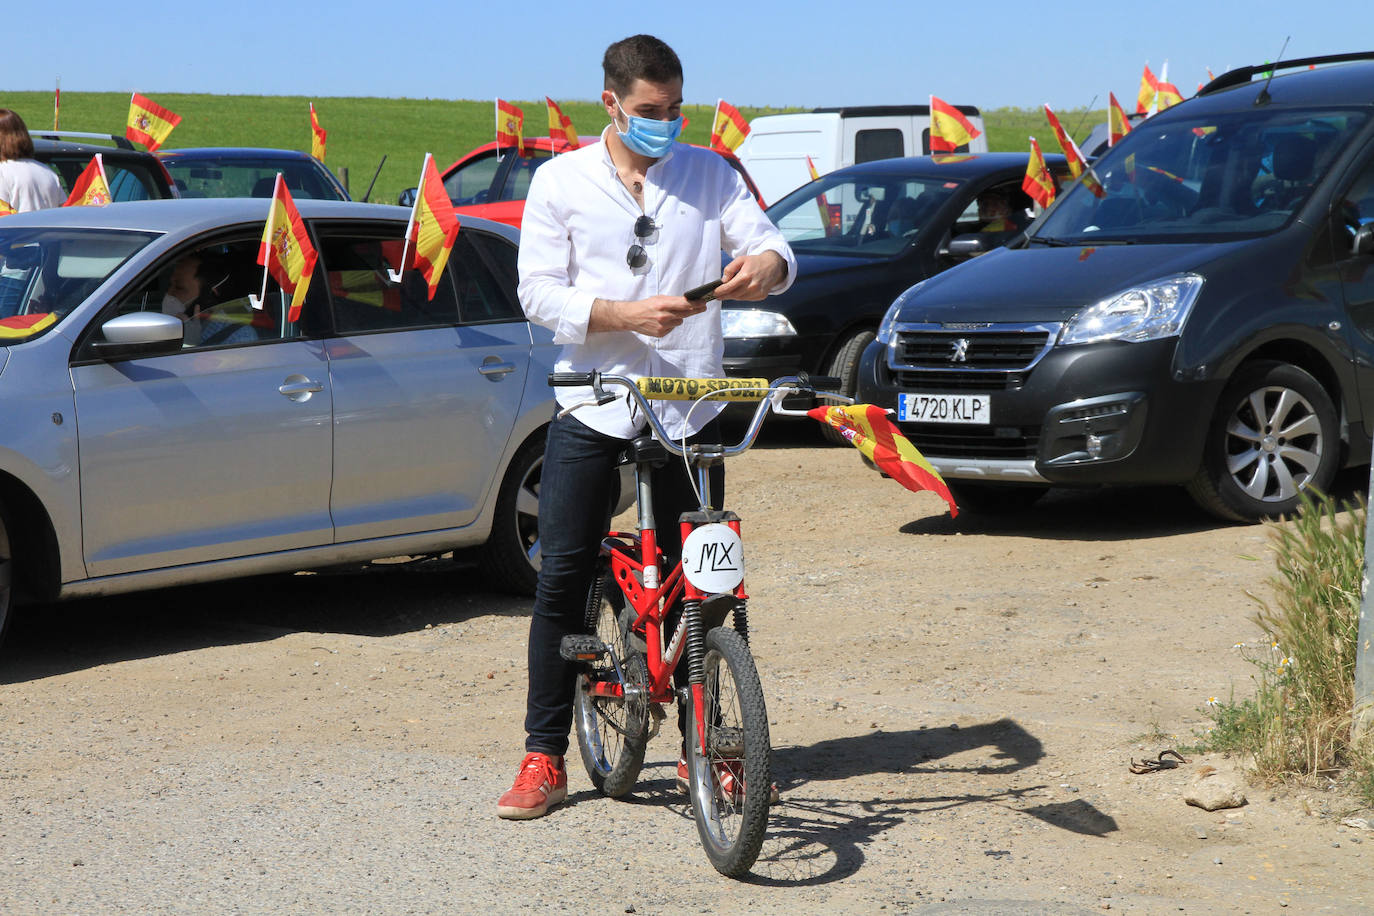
[1059,273,1202,343]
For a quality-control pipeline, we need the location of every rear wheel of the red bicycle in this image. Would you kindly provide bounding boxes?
[573,574,650,798]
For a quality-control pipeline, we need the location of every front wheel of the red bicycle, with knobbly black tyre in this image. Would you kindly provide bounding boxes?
[687,626,772,878]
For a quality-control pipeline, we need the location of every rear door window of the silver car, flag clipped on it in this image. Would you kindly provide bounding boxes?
[320,224,462,334]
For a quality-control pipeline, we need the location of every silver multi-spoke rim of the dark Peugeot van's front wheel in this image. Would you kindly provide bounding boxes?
[1226,386,1326,503]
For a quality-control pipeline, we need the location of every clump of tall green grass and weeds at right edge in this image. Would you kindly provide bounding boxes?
[1205,493,1374,805]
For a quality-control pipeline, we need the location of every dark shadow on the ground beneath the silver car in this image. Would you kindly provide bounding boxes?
[0,556,530,684]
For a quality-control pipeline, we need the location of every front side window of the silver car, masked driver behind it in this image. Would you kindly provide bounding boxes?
[100,235,320,349]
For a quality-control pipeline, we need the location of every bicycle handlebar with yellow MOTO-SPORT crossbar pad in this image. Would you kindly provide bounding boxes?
[548,371,853,457]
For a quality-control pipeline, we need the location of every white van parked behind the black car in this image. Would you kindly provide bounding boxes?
[735,104,988,203]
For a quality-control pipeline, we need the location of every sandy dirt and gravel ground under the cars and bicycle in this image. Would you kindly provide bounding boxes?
[0,430,1374,913]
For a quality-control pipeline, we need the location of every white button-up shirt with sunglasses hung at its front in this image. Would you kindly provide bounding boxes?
[519,126,797,439]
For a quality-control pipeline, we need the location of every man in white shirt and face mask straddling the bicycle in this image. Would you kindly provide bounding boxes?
[496,34,797,818]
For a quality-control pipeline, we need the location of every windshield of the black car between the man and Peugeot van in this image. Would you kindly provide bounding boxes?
[767,170,962,258]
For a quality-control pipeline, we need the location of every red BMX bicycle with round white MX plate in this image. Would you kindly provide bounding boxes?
[550,372,851,876]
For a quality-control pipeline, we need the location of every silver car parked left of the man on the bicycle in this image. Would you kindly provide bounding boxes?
[0,199,574,645]
